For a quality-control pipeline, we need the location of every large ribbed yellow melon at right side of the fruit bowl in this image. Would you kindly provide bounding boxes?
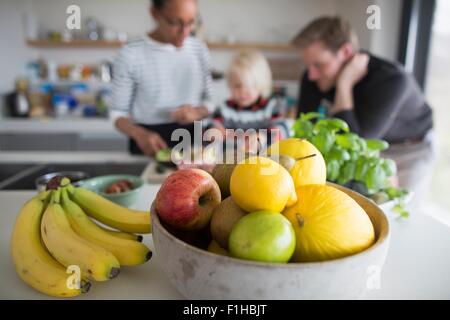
[283,185,375,262]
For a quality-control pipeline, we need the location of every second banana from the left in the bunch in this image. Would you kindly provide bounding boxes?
[41,189,120,281]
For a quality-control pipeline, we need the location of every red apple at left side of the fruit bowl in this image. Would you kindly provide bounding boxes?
[155,169,221,230]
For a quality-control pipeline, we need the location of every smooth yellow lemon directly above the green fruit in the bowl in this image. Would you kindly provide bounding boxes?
[230,156,297,212]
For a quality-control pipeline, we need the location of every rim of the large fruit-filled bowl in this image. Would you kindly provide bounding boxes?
[150,182,390,269]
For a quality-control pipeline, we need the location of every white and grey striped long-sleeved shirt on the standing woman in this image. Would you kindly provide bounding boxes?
[110,36,213,124]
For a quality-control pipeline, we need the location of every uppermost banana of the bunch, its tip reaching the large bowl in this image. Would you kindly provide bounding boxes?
[68,185,151,234]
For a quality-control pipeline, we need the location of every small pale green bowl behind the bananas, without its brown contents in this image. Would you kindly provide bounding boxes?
[80,174,144,207]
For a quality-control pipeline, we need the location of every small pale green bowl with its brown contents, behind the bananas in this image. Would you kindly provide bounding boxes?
[80,174,144,207]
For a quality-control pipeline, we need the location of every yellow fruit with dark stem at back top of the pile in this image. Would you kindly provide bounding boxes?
[267,138,327,187]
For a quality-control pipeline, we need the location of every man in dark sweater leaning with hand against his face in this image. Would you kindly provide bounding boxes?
[293,17,433,201]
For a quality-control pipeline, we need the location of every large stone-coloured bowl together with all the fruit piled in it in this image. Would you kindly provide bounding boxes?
[151,139,389,299]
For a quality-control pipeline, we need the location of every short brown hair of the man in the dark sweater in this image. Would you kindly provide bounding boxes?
[292,16,359,52]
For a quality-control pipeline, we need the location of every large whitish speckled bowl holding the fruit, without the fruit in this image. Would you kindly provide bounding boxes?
[151,185,389,300]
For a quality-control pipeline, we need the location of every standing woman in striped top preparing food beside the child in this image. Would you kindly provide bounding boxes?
[111,0,212,156]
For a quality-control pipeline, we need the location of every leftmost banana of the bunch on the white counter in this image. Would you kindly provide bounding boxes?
[11,191,91,297]
